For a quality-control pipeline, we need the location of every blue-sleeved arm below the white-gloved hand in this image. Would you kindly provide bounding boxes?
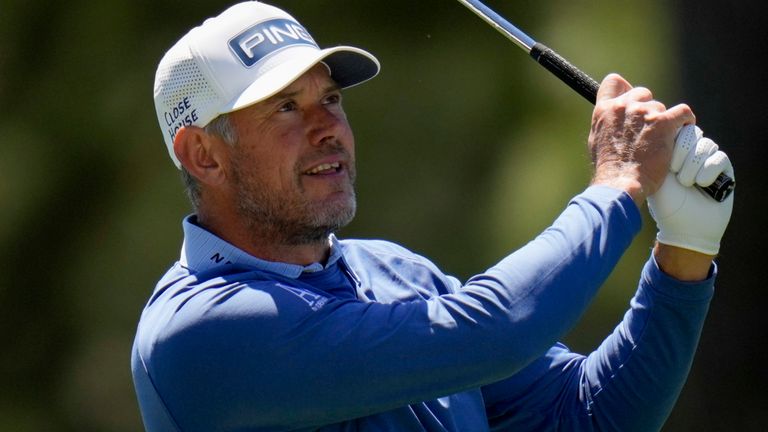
[483,254,715,432]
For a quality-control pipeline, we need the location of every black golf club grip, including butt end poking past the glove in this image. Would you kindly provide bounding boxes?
[530,42,736,202]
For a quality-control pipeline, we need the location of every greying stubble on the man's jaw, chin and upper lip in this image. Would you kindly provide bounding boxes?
[232,142,357,246]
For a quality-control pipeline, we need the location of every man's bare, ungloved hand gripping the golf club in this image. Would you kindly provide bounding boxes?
[589,74,696,207]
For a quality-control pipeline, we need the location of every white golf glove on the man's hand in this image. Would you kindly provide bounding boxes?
[648,125,736,255]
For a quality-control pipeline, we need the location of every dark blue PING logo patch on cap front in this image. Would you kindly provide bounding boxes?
[229,18,319,67]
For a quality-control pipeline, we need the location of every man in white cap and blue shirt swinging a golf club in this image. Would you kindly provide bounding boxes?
[132,2,733,431]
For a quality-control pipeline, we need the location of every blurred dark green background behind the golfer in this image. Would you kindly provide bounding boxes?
[0,0,768,431]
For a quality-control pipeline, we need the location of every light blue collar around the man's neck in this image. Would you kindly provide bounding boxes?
[179,215,341,279]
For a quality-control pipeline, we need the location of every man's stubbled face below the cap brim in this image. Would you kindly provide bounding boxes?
[224,64,355,245]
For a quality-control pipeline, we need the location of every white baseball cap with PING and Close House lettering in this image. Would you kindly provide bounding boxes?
[155,1,379,168]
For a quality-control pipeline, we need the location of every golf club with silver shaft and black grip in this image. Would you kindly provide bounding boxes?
[458,0,736,202]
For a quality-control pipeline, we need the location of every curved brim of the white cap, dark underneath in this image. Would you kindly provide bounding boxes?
[219,46,380,114]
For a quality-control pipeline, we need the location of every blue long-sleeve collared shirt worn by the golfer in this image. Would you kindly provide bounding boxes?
[132,187,715,431]
